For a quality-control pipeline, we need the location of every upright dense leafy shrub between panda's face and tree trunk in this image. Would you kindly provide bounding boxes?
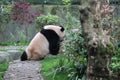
[65,27,87,80]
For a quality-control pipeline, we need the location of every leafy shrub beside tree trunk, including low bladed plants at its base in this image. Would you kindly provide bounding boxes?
[55,27,87,80]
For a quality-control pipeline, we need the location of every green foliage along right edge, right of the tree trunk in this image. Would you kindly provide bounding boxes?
[110,17,120,76]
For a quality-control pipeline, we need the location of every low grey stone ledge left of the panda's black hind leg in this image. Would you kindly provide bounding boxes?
[0,50,22,63]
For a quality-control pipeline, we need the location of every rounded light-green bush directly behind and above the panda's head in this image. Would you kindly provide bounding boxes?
[36,13,59,28]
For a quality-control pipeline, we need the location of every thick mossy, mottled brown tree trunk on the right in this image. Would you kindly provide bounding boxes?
[80,0,114,80]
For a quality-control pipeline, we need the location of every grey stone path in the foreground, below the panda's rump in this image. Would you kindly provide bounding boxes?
[3,60,43,80]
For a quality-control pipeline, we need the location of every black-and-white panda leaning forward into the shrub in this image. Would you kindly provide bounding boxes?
[20,25,65,61]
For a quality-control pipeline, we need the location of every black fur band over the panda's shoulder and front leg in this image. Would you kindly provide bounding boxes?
[41,29,60,55]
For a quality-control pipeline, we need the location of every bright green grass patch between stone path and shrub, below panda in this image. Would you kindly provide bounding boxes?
[41,55,68,80]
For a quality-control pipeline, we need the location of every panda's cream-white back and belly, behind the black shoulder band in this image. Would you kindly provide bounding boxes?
[26,32,49,57]
